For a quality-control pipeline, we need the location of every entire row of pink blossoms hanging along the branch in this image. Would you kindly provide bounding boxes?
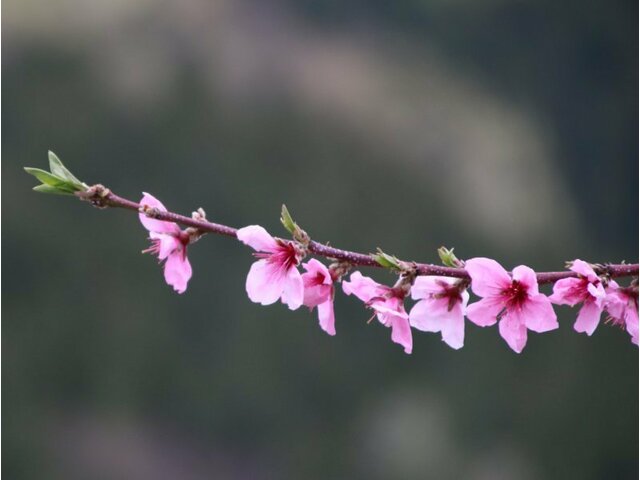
[140,193,638,353]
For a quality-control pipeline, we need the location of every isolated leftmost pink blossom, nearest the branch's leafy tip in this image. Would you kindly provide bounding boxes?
[139,192,192,293]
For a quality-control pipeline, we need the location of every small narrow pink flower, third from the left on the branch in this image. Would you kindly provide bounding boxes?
[302,258,336,335]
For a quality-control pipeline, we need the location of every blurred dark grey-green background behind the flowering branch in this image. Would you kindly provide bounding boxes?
[2,0,638,480]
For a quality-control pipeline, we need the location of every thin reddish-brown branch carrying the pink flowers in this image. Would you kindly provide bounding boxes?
[74,185,638,284]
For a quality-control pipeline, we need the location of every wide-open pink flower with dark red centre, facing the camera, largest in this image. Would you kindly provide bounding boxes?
[465,258,558,353]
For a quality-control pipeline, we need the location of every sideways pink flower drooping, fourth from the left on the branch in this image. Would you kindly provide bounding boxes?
[342,272,413,353]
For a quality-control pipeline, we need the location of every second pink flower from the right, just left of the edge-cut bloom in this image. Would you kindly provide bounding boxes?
[549,260,606,335]
